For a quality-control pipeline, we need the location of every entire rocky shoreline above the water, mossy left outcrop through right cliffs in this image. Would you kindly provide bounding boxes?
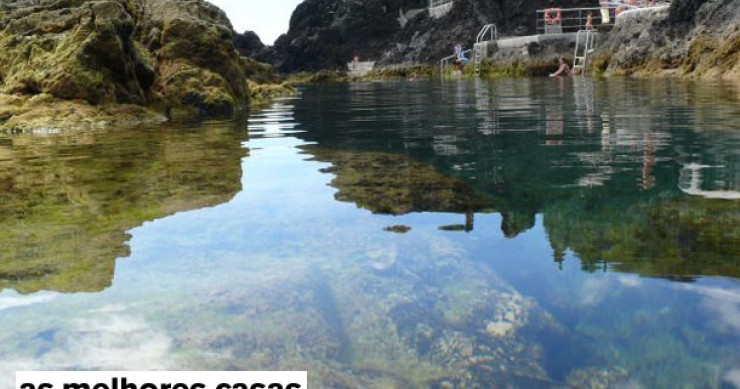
[0,0,740,132]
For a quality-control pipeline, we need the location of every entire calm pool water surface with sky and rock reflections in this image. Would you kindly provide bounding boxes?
[0,79,740,388]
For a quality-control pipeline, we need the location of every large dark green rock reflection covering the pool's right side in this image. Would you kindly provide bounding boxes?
[296,78,740,280]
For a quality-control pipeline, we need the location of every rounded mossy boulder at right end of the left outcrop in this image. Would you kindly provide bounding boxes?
[136,0,249,115]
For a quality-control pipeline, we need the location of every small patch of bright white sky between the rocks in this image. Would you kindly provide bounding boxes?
[208,0,302,45]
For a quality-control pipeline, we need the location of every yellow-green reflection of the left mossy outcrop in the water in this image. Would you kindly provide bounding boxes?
[0,123,245,293]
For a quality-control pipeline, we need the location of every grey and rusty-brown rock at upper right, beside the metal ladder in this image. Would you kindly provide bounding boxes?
[594,0,740,80]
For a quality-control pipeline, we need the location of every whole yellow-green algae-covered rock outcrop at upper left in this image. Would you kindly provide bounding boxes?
[0,0,284,130]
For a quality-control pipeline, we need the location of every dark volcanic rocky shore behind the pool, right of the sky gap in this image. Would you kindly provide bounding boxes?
[276,0,740,81]
